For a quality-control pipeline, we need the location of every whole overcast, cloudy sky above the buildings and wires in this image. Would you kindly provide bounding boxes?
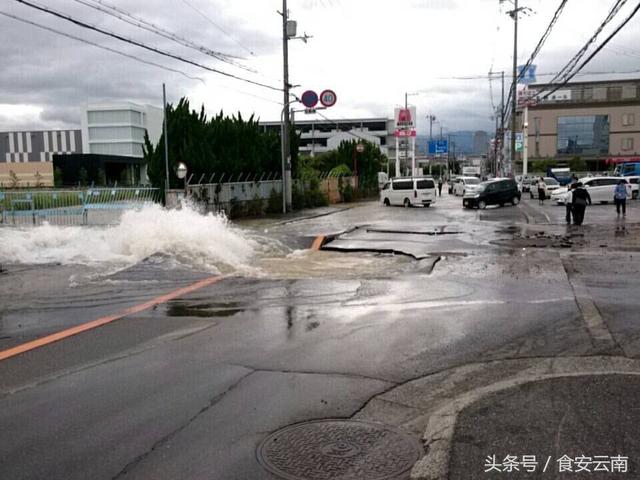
[0,0,640,133]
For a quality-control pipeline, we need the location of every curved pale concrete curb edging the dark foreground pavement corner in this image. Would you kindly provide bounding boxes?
[411,357,640,480]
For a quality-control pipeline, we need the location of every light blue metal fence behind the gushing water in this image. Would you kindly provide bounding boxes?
[0,187,160,226]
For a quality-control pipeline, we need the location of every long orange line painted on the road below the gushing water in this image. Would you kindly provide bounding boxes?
[0,275,224,361]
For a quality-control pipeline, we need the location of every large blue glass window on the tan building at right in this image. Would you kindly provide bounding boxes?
[557,115,609,155]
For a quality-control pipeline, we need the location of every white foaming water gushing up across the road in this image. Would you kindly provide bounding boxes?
[0,205,267,273]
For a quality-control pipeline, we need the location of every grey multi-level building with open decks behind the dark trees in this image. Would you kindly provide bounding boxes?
[260,118,395,158]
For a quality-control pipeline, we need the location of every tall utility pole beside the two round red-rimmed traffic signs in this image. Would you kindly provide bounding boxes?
[281,0,292,212]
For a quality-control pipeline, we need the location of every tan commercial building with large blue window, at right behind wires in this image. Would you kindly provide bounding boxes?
[517,79,640,171]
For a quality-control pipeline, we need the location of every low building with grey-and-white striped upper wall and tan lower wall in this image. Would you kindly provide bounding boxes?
[0,130,83,187]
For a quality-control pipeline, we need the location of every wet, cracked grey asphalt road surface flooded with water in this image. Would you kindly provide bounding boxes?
[0,189,640,480]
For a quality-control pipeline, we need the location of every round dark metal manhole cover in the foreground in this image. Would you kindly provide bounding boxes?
[258,420,422,480]
